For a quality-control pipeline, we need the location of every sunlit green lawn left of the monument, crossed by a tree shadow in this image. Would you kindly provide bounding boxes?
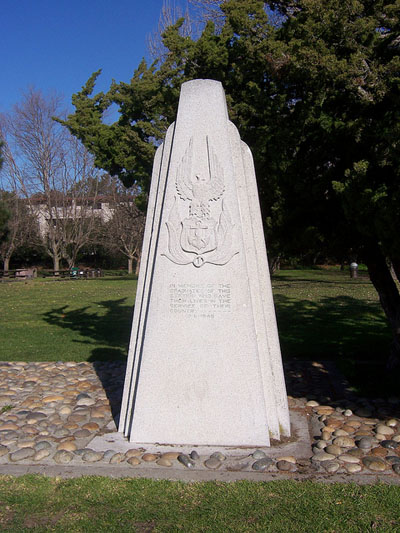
[0,278,137,361]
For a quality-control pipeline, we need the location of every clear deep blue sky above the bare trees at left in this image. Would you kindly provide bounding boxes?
[0,0,169,112]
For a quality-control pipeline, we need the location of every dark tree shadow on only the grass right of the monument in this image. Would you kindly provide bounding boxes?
[275,294,391,360]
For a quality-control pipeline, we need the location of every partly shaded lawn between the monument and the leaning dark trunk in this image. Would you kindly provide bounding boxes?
[272,269,391,361]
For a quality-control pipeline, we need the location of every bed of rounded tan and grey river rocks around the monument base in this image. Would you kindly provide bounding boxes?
[0,361,400,479]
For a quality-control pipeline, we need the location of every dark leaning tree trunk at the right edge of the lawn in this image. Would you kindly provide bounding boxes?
[365,245,400,370]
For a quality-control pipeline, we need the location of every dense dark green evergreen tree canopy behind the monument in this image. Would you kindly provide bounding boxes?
[63,0,400,364]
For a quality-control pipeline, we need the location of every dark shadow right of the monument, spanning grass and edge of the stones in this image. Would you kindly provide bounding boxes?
[275,294,398,401]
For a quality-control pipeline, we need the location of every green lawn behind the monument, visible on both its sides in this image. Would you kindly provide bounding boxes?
[0,269,391,388]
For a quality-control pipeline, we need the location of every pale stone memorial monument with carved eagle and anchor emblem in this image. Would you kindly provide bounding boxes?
[119,80,290,446]
